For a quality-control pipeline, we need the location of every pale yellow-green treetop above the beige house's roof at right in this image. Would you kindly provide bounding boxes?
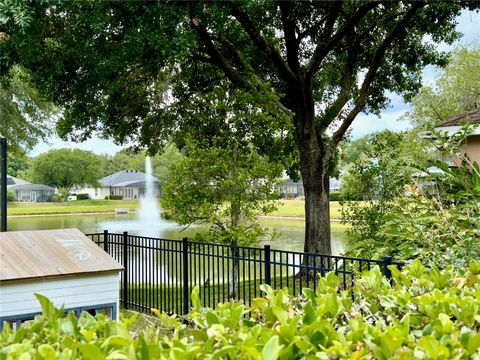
[407,44,480,129]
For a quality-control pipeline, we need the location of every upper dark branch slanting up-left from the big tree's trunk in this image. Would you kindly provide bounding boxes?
[227,5,298,82]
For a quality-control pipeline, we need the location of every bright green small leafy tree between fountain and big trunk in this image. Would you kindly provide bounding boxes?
[161,146,281,245]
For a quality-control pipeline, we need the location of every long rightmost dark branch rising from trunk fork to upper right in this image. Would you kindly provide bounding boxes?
[329,1,425,155]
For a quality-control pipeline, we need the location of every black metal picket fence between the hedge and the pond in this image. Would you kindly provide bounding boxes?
[87,231,402,314]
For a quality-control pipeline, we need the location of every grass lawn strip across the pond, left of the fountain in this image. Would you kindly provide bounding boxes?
[7,200,139,215]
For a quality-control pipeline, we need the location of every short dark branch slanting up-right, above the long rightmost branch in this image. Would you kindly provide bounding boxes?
[305,2,378,79]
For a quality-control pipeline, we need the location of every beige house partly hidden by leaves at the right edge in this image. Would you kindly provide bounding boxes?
[437,109,480,165]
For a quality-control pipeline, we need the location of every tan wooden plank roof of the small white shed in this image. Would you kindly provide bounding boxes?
[0,229,123,282]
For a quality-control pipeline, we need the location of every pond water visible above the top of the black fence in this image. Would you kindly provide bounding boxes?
[8,214,347,254]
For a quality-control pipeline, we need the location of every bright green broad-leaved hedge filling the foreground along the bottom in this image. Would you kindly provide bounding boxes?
[0,261,480,359]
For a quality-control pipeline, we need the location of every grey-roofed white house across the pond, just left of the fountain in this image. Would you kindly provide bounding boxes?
[76,170,160,199]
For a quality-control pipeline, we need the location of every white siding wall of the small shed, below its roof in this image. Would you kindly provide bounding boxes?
[0,274,120,317]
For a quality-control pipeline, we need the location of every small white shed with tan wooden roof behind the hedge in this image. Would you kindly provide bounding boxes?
[0,229,123,329]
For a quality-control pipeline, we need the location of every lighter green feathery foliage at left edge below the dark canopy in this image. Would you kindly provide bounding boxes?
[0,66,56,152]
